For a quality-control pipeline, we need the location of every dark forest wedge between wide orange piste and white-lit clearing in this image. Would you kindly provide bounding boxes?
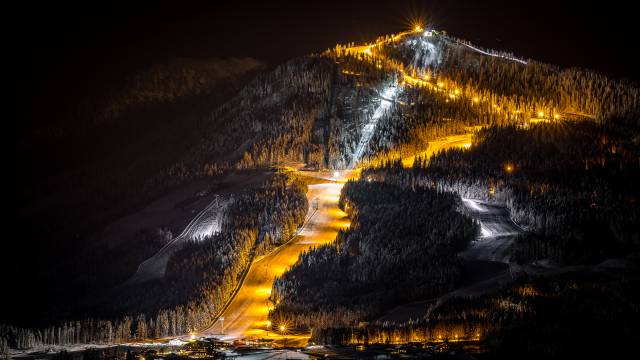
[270,180,477,329]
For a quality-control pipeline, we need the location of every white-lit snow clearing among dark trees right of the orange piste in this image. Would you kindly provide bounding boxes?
[461,198,522,263]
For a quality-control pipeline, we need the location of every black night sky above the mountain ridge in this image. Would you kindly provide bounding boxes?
[13,0,639,125]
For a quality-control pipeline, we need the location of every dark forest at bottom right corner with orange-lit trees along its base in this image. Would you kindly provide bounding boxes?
[313,268,640,359]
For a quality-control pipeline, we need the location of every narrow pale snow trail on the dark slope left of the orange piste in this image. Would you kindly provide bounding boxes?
[126,195,231,284]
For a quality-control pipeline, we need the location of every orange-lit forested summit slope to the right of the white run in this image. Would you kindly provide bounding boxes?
[326,34,640,165]
